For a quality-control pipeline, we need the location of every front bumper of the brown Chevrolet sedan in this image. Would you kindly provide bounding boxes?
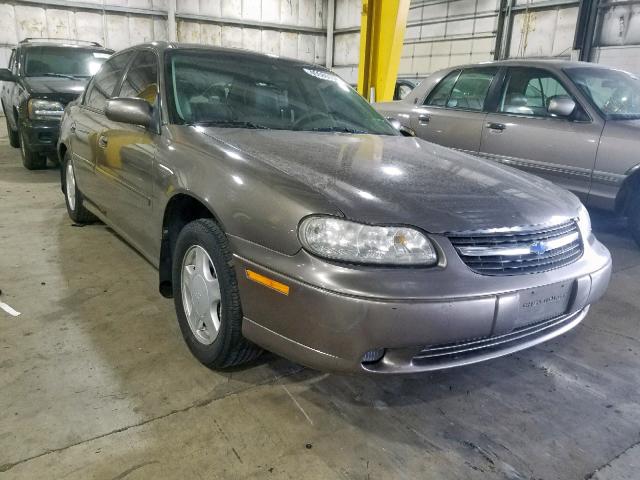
[231,231,611,373]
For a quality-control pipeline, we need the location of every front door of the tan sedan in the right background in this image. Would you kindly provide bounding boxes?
[480,67,604,201]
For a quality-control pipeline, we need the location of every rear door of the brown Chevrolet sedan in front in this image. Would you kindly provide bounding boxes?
[71,51,133,202]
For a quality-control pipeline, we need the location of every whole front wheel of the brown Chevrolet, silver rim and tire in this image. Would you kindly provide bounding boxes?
[172,219,261,368]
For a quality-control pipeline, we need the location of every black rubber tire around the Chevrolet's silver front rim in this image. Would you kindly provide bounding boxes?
[172,218,262,369]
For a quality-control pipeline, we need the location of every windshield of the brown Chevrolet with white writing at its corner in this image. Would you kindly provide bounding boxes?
[167,50,398,135]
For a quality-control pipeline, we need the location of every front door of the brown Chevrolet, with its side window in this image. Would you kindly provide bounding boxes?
[96,50,158,255]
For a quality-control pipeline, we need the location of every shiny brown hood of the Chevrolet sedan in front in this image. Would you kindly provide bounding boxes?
[202,128,580,233]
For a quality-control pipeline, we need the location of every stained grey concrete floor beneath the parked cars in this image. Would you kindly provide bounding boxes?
[0,128,640,480]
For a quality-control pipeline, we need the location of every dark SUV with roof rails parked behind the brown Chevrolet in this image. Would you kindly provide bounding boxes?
[0,38,113,170]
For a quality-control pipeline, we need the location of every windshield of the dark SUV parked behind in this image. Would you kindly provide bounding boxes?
[24,46,111,78]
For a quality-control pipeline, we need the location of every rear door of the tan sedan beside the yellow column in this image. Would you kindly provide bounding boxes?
[411,67,498,153]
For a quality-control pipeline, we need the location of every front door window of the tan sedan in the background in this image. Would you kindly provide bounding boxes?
[498,68,571,117]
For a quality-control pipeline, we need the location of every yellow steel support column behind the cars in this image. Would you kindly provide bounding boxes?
[358,0,410,102]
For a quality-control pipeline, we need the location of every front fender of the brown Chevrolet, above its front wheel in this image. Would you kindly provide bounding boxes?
[154,126,341,255]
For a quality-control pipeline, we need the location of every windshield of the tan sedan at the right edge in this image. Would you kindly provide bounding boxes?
[566,67,640,119]
